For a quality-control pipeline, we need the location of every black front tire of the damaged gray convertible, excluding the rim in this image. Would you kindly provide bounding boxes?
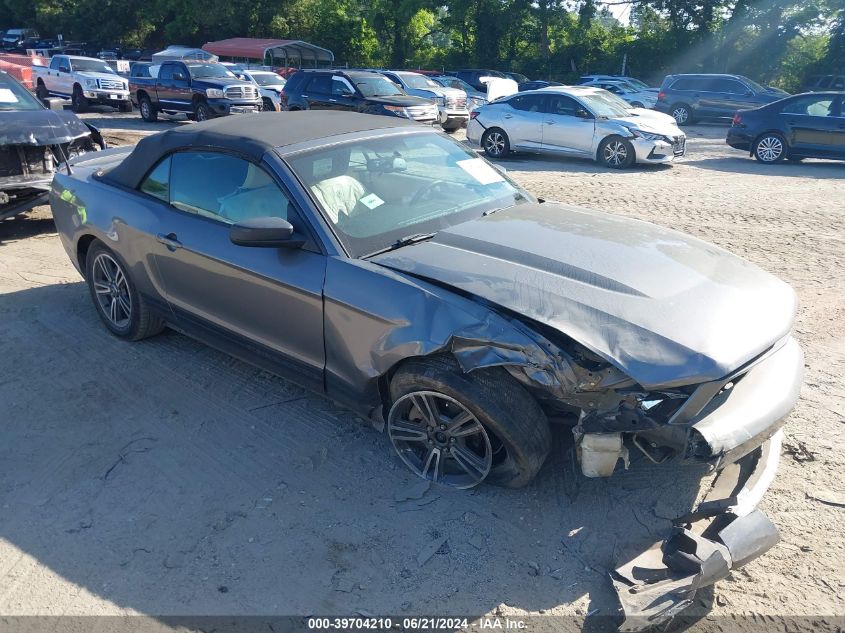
[389,356,552,488]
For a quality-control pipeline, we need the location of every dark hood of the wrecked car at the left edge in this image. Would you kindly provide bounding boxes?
[0,110,91,145]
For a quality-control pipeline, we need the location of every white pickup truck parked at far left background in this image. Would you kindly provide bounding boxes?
[32,55,132,112]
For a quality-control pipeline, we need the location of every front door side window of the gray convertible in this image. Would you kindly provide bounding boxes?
[170,152,290,224]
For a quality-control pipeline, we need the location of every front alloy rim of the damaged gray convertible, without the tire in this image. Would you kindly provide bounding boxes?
[387,391,493,488]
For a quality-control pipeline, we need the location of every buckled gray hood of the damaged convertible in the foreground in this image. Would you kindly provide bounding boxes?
[372,203,795,389]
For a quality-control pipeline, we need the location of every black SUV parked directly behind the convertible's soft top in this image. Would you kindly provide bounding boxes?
[281,70,437,124]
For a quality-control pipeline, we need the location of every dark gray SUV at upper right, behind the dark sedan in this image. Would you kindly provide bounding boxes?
[654,74,788,125]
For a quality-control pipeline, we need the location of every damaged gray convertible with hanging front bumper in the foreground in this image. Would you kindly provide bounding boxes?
[51,112,803,630]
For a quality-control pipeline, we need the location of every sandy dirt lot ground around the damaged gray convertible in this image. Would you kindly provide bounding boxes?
[0,114,845,630]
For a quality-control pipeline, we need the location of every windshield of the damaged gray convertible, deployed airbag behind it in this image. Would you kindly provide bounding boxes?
[289,131,532,257]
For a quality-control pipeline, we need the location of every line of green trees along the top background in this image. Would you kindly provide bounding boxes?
[0,0,845,91]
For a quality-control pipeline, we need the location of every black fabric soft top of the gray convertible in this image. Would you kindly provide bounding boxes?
[102,111,419,189]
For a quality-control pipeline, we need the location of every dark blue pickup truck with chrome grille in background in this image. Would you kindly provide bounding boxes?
[129,61,262,121]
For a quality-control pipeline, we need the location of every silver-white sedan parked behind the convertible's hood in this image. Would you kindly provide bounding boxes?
[467,86,686,169]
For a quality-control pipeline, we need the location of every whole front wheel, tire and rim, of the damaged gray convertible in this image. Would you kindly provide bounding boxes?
[387,356,551,488]
